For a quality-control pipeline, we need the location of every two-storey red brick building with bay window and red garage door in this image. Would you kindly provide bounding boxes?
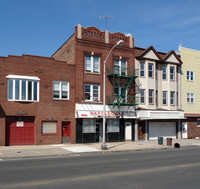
[0,55,75,145]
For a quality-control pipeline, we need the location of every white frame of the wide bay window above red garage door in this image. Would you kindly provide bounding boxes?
[6,75,40,102]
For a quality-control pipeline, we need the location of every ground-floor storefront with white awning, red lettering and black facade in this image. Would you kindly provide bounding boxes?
[76,104,135,143]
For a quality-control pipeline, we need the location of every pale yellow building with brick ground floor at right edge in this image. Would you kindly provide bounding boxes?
[177,46,200,138]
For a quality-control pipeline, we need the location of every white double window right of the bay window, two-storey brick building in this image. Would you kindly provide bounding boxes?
[53,81,69,100]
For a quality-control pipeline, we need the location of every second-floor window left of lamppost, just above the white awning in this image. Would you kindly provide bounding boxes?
[85,84,100,101]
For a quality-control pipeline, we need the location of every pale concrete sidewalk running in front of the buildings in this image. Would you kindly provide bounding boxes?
[0,139,200,160]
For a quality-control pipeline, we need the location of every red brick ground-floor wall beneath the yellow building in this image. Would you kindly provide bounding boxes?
[187,117,200,138]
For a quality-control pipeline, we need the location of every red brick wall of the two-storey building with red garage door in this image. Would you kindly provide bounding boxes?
[0,55,75,145]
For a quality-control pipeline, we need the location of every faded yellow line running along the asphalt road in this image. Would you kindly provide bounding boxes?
[0,163,200,189]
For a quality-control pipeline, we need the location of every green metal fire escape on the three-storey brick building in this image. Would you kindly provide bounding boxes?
[107,65,138,107]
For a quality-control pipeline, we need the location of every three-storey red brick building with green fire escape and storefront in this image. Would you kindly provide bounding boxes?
[52,25,137,143]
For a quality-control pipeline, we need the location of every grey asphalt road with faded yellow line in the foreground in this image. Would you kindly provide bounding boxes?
[0,147,200,189]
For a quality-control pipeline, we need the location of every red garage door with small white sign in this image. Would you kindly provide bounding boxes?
[6,117,34,145]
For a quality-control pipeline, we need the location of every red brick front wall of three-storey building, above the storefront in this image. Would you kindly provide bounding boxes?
[75,39,135,103]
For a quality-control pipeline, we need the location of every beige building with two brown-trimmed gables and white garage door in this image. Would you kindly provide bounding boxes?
[135,46,184,140]
